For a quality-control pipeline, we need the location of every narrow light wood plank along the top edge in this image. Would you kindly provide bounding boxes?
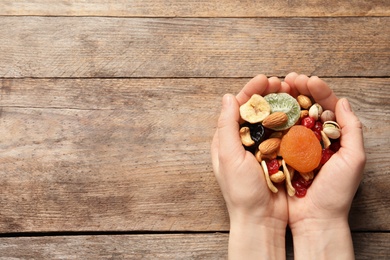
[0,0,390,17]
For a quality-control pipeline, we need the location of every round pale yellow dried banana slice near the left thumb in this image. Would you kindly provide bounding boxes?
[240,94,271,124]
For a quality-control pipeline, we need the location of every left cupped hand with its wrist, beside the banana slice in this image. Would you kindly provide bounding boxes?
[211,75,290,259]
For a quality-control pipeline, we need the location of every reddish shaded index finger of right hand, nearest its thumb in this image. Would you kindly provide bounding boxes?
[307,76,338,111]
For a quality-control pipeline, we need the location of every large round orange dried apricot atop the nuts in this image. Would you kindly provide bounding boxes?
[280,125,322,173]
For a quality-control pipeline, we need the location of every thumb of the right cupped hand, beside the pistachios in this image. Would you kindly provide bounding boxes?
[335,98,366,167]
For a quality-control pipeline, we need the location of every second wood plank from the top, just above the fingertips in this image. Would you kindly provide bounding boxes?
[0,16,390,78]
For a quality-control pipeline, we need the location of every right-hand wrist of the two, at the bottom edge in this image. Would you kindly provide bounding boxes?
[290,218,354,259]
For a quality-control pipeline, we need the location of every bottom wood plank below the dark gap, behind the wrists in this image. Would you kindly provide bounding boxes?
[0,233,390,260]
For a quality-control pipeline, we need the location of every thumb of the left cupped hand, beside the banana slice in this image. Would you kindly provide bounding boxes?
[218,94,245,160]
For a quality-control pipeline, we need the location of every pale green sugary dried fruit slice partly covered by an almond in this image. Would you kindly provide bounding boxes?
[264,93,301,131]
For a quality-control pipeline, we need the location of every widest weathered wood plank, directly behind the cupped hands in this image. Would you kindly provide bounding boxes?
[0,78,390,233]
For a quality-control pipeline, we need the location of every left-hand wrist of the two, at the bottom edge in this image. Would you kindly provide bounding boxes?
[229,215,286,259]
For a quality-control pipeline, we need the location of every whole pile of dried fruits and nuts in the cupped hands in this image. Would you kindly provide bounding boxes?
[240,93,341,197]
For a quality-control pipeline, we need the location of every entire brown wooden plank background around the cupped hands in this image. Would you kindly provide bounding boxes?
[0,0,390,259]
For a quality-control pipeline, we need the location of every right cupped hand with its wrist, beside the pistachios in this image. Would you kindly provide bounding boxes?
[285,73,366,259]
